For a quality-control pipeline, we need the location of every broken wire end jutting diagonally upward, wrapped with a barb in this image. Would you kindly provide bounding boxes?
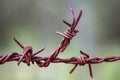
[41,7,82,67]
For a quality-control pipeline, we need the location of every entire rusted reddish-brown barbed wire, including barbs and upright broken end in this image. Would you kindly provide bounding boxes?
[0,7,120,77]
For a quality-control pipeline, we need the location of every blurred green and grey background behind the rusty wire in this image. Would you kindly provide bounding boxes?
[0,0,120,80]
